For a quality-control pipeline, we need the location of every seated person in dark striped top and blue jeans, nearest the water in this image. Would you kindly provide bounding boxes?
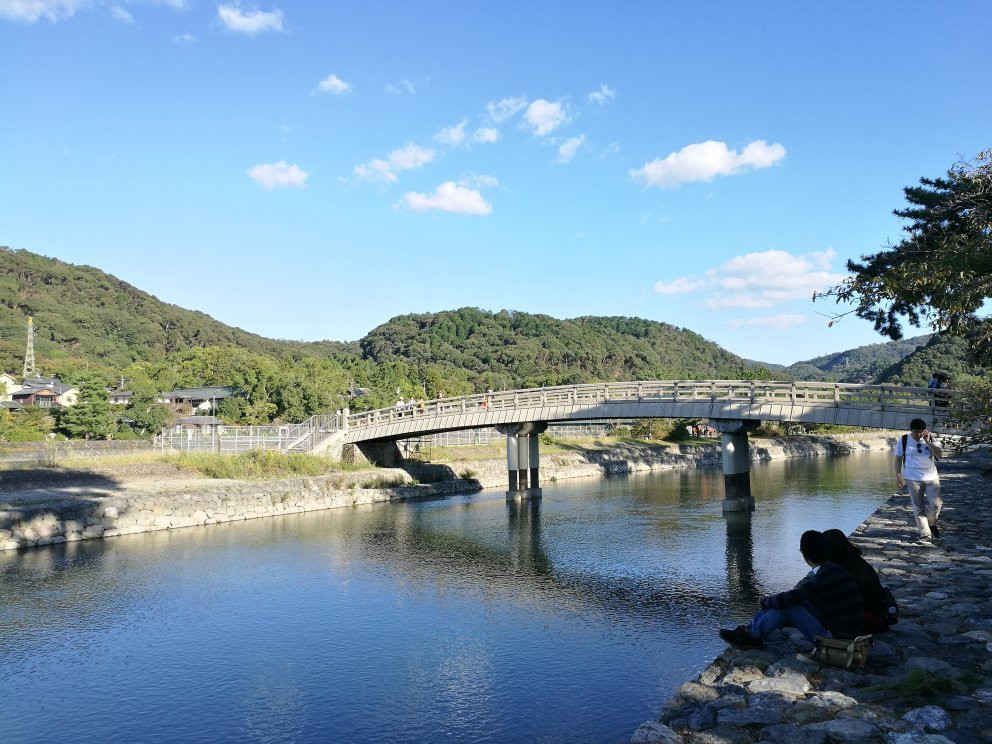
[720,530,862,648]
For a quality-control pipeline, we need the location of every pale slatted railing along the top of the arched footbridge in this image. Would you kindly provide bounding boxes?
[348,380,948,428]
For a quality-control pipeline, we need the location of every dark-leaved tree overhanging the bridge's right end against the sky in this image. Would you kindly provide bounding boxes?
[814,150,992,362]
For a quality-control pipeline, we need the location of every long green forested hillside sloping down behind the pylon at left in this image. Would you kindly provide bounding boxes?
[0,246,357,371]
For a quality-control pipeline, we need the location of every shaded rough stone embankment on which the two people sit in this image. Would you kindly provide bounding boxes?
[632,455,992,744]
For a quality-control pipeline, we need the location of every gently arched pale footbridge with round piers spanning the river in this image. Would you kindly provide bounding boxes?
[295,380,950,511]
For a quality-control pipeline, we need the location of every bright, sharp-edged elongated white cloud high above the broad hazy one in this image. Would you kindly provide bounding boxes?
[629,140,785,188]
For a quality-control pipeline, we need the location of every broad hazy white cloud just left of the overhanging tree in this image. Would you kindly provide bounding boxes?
[655,248,845,310]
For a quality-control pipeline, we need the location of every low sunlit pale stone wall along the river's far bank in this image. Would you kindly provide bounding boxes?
[0,434,894,550]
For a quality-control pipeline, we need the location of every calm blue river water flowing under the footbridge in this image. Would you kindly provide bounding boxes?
[0,454,892,744]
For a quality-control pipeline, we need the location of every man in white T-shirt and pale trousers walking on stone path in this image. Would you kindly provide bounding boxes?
[895,419,944,541]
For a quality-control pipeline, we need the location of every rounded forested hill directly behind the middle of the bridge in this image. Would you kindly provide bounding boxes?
[360,308,756,388]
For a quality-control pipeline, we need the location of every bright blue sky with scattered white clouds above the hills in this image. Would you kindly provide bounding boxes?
[0,0,992,364]
